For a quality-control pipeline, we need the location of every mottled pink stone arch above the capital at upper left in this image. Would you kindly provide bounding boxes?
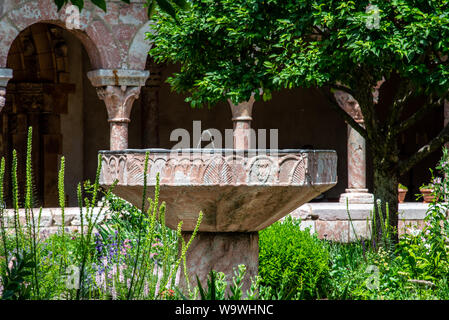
[0,0,148,70]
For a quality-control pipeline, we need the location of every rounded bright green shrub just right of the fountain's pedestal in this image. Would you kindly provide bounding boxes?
[259,217,329,299]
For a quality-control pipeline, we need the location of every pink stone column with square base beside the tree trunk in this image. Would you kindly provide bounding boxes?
[335,91,374,203]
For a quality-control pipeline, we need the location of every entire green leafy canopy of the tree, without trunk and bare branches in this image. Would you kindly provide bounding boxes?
[148,0,449,106]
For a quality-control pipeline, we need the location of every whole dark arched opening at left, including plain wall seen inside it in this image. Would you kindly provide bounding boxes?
[0,23,108,207]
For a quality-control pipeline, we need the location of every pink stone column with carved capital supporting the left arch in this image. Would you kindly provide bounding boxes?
[87,69,150,150]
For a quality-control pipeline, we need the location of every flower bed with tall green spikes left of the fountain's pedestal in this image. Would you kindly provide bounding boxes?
[0,128,202,300]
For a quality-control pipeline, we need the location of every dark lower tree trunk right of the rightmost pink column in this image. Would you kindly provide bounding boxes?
[372,156,399,246]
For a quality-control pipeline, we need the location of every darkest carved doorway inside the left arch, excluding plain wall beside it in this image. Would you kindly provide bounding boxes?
[0,23,75,207]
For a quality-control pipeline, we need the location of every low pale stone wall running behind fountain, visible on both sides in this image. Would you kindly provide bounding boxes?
[0,202,438,242]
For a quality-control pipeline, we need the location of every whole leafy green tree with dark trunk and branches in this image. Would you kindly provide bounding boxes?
[149,0,449,241]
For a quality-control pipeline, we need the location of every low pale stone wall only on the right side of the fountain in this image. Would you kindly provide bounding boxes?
[291,202,429,242]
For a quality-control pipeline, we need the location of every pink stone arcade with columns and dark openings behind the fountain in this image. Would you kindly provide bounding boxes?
[0,0,444,207]
